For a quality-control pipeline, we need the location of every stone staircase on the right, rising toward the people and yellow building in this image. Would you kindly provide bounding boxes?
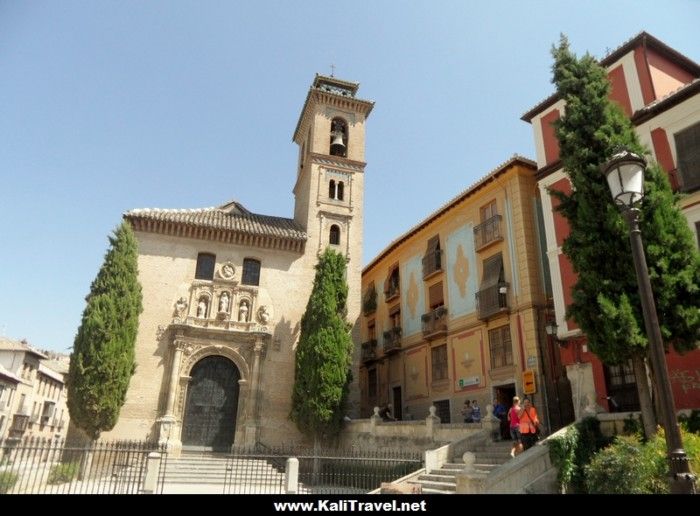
[409,441,511,494]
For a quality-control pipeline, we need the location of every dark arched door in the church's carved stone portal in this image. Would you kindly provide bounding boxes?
[182,356,240,451]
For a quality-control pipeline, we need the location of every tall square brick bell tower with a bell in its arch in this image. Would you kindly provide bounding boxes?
[293,74,374,417]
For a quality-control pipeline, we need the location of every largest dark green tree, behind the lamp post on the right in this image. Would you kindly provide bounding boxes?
[552,36,700,433]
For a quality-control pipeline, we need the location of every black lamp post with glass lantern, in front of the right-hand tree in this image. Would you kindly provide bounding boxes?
[602,150,695,494]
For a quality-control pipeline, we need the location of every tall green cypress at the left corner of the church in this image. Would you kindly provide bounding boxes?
[68,222,143,440]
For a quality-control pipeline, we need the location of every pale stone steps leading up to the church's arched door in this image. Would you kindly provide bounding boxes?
[164,453,284,494]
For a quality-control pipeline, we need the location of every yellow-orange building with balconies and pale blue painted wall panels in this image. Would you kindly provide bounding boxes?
[360,156,550,423]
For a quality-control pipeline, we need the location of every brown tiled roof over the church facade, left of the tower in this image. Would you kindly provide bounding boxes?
[124,201,307,241]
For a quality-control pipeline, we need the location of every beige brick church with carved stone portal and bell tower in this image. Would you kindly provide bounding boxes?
[102,75,374,451]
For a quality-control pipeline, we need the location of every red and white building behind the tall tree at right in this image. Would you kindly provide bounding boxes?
[522,32,700,417]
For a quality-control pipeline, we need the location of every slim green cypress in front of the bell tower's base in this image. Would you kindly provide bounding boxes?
[290,249,352,446]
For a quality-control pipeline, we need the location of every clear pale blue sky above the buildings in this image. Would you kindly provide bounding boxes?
[0,0,700,351]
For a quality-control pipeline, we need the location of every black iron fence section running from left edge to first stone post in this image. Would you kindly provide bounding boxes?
[0,438,167,494]
